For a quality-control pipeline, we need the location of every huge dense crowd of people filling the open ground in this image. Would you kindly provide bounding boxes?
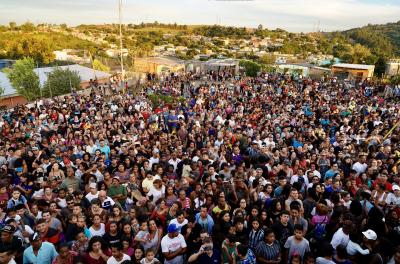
[0,72,400,264]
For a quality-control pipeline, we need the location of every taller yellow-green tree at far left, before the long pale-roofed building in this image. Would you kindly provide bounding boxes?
[7,58,40,101]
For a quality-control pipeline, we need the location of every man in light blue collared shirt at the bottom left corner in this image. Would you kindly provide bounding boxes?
[23,233,58,264]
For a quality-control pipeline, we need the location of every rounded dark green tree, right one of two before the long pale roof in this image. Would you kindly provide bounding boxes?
[43,67,81,96]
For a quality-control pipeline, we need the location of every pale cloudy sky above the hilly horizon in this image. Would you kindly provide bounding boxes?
[0,0,400,32]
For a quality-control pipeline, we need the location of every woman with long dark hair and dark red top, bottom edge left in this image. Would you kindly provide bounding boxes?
[85,236,110,264]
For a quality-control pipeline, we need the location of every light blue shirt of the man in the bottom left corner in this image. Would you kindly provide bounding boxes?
[23,242,58,264]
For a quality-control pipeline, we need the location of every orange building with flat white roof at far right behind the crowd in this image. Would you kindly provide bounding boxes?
[331,63,375,81]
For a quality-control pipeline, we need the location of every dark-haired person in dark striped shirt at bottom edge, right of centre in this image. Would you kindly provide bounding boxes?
[255,229,282,264]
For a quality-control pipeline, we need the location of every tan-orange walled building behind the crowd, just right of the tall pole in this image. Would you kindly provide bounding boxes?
[134,57,185,74]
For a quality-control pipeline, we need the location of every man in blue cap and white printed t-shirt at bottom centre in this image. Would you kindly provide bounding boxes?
[161,224,187,264]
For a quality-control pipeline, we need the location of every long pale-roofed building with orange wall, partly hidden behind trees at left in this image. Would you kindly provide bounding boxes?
[0,64,111,107]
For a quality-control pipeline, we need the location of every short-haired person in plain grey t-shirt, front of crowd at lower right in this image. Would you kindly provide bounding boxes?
[284,224,311,263]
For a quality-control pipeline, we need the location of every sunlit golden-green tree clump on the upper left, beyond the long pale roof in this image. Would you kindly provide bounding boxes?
[6,36,55,64]
